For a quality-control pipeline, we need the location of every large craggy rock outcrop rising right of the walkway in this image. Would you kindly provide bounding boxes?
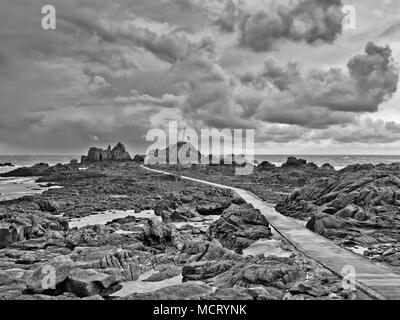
[276,164,400,262]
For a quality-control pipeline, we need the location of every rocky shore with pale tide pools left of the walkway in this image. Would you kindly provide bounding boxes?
[0,151,367,300]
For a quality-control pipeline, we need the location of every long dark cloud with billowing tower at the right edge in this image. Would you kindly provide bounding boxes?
[240,43,399,128]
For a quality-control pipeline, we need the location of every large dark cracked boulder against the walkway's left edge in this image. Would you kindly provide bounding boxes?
[207,204,272,253]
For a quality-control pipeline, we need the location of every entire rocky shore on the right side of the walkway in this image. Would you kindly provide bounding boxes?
[154,158,400,269]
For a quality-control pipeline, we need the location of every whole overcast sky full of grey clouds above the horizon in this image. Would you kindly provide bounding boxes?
[0,0,400,154]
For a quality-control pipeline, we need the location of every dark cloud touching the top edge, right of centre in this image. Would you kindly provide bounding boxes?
[240,0,342,51]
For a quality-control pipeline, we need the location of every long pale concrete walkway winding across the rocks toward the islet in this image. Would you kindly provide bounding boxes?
[142,166,400,300]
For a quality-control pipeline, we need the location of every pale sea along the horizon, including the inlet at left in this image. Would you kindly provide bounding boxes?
[0,155,400,201]
